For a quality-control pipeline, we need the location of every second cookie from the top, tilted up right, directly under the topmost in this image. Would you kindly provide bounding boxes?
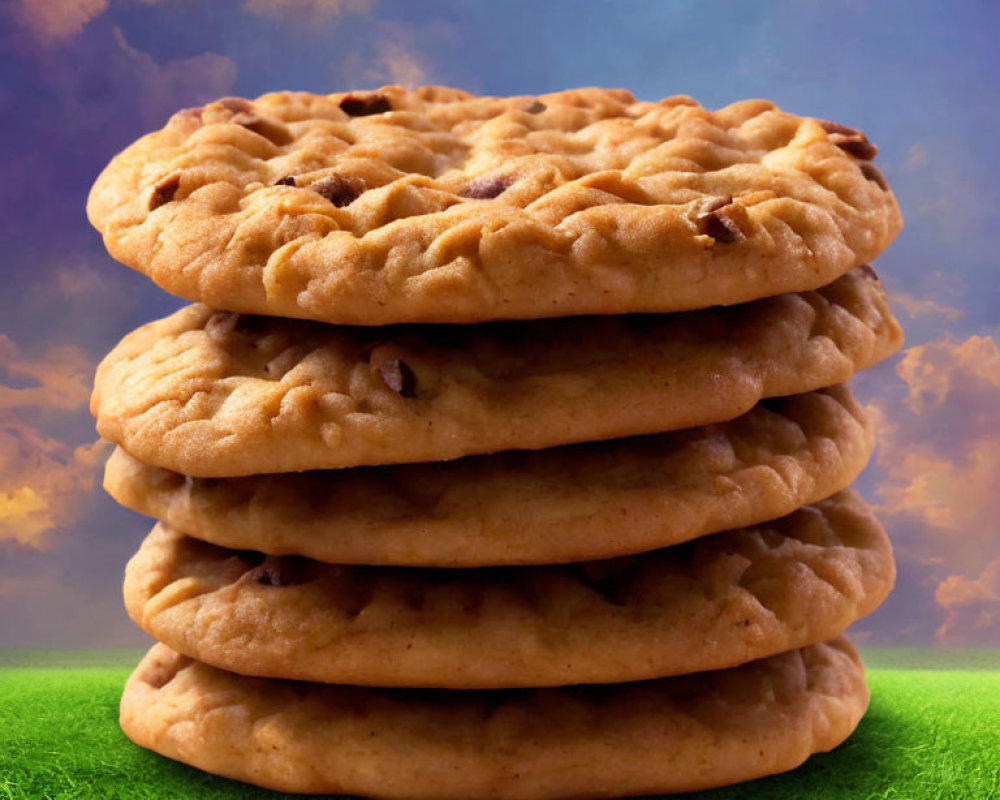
[91,267,902,477]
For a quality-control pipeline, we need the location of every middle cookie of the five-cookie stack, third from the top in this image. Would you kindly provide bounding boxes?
[104,386,873,567]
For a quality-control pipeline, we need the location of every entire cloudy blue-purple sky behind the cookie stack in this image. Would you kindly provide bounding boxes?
[0,0,1000,648]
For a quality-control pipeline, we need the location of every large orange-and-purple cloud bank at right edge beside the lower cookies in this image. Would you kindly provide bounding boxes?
[872,336,1000,644]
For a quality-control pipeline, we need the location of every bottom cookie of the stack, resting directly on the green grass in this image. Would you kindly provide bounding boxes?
[121,638,868,800]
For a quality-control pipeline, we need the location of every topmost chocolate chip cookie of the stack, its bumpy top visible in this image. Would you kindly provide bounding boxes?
[87,86,902,325]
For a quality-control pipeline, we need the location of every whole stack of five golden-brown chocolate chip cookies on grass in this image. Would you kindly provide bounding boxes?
[88,87,902,800]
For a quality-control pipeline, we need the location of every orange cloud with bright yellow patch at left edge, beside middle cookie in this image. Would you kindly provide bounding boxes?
[0,419,106,550]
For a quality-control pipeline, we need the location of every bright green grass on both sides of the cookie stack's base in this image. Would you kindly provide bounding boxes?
[0,659,1000,800]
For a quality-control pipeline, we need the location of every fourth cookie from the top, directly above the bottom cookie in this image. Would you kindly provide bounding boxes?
[125,490,895,689]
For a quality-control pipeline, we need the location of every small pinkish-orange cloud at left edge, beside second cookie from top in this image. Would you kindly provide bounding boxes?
[0,334,94,411]
